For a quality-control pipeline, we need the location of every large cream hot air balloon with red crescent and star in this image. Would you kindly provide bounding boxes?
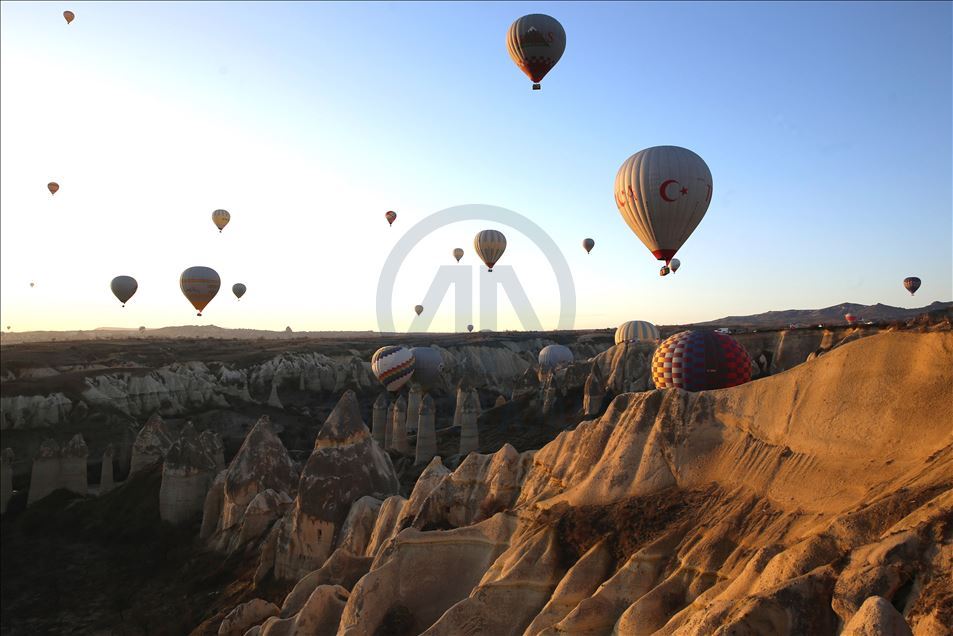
[615,146,712,265]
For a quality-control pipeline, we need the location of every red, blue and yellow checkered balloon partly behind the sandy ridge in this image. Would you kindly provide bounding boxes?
[652,331,751,391]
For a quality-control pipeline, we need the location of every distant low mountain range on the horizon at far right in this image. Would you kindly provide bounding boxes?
[694,301,953,329]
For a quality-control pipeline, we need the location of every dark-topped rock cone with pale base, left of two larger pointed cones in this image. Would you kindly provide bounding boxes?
[159,422,216,524]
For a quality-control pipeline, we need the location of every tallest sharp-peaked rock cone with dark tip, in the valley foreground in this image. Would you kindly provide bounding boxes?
[274,391,398,580]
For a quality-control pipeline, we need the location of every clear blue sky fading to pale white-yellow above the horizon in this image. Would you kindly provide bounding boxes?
[0,2,953,331]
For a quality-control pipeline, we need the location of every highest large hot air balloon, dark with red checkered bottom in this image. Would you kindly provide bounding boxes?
[506,13,566,91]
